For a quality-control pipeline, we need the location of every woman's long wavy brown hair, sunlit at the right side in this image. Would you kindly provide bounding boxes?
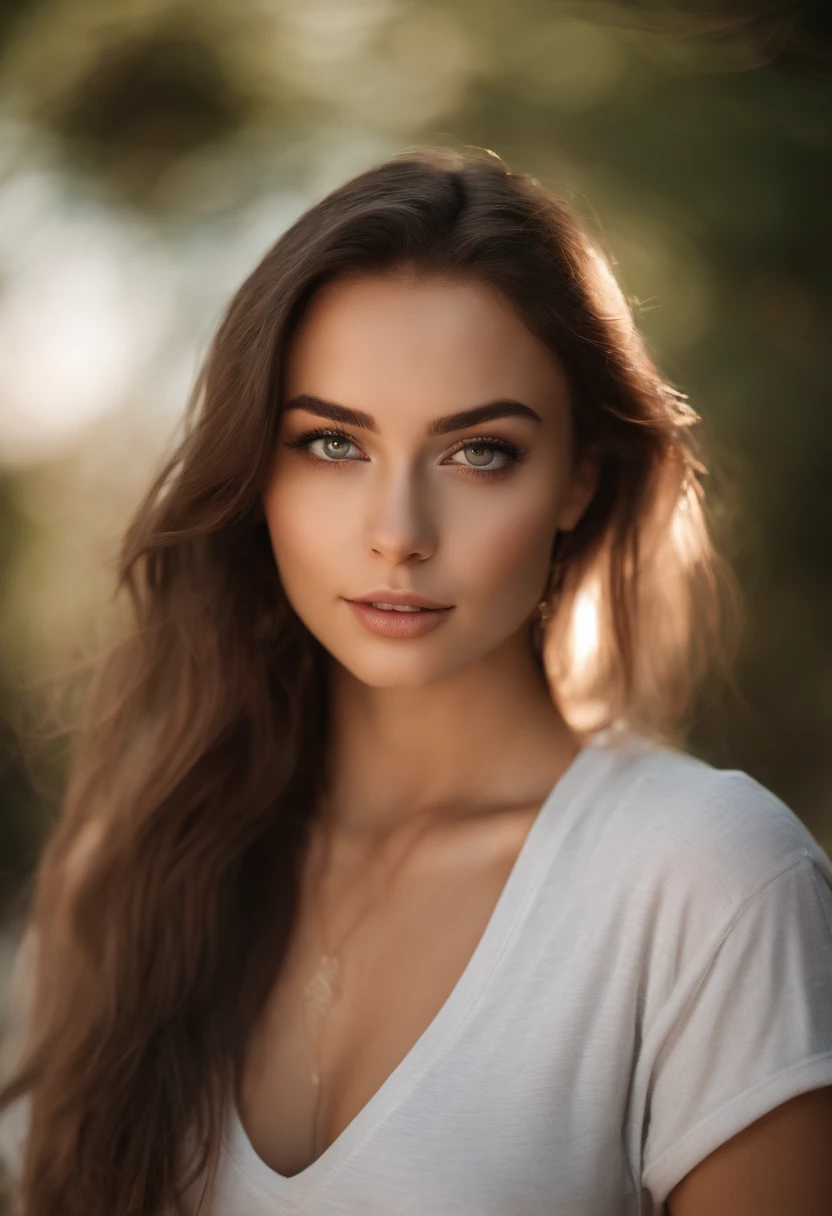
[0,148,736,1216]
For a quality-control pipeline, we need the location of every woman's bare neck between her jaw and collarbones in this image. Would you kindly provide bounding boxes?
[316,636,581,838]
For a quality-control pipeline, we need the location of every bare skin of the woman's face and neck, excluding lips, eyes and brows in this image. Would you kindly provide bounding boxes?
[264,274,597,837]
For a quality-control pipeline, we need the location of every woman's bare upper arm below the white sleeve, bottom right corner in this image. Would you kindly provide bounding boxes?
[668,1086,832,1216]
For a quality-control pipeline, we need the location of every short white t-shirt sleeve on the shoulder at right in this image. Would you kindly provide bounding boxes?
[642,851,832,1210]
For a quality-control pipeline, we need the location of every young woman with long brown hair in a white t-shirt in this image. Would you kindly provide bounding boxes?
[2,150,832,1216]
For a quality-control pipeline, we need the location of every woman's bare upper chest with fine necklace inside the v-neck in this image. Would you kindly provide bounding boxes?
[238,807,536,1177]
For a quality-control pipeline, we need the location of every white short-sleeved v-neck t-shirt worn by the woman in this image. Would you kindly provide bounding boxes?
[1,732,832,1216]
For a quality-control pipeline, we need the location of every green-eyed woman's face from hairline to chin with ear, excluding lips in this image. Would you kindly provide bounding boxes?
[264,275,595,687]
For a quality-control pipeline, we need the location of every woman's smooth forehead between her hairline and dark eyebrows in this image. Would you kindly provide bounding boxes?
[285,274,567,412]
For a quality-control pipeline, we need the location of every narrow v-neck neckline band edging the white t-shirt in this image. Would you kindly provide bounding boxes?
[223,730,617,1210]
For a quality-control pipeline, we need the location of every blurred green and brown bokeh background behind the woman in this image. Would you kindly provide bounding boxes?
[0,0,832,1181]
